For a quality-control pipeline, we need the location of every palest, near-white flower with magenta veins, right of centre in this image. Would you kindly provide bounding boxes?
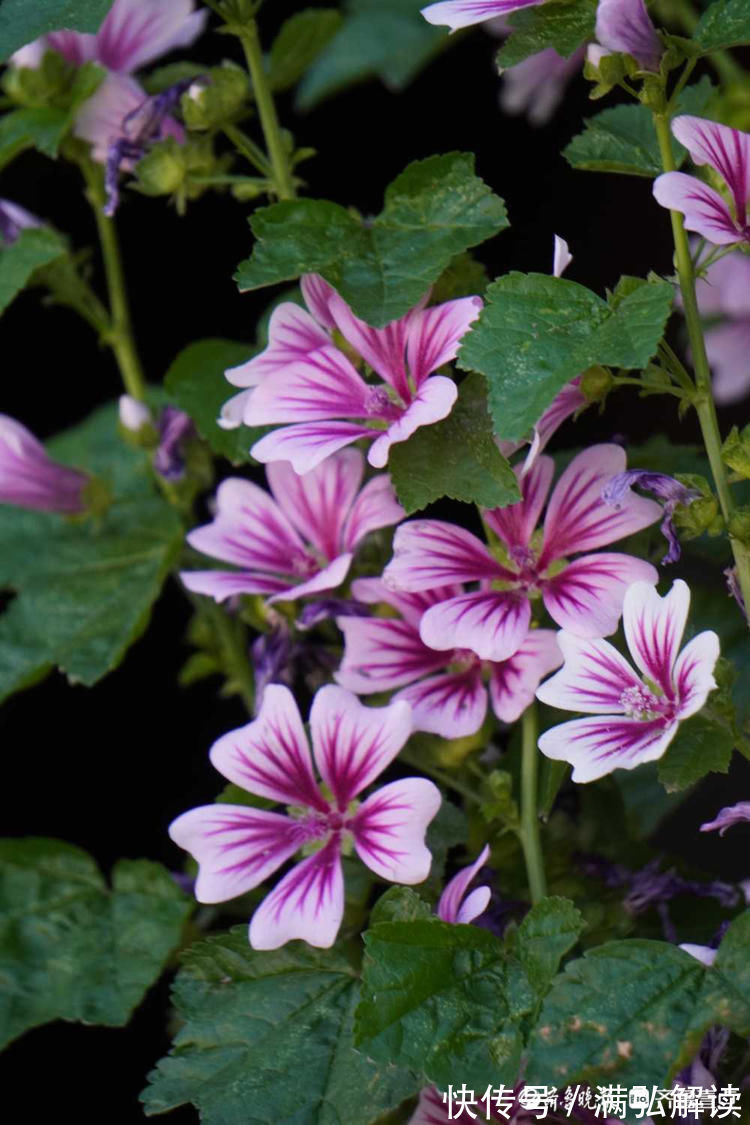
[536,579,719,782]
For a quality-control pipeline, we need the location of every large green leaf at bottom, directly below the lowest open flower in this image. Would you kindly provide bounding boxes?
[143,927,418,1125]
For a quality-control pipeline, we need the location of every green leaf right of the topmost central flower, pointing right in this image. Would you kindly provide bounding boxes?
[459,273,674,441]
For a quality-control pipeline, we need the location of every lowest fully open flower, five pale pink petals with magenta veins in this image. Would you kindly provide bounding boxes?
[170,684,441,950]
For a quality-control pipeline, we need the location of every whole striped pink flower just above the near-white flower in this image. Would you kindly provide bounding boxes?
[383,446,661,662]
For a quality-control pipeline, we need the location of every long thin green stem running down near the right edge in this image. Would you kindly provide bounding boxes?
[653,114,750,621]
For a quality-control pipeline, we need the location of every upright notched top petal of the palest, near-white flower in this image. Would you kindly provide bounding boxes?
[623,578,690,699]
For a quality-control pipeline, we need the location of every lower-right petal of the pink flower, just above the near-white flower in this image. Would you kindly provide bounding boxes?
[542,551,659,637]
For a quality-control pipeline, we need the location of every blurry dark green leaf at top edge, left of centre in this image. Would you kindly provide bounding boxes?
[297,0,450,109]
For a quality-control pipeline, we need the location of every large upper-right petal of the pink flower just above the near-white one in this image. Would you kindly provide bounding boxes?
[539,444,661,568]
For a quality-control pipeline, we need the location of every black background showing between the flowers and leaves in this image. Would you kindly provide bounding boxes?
[0,0,747,1125]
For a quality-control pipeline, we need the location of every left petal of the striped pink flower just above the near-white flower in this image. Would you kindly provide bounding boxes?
[383,520,503,592]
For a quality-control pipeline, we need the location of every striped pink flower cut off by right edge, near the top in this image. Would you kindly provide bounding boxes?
[653,115,750,246]
